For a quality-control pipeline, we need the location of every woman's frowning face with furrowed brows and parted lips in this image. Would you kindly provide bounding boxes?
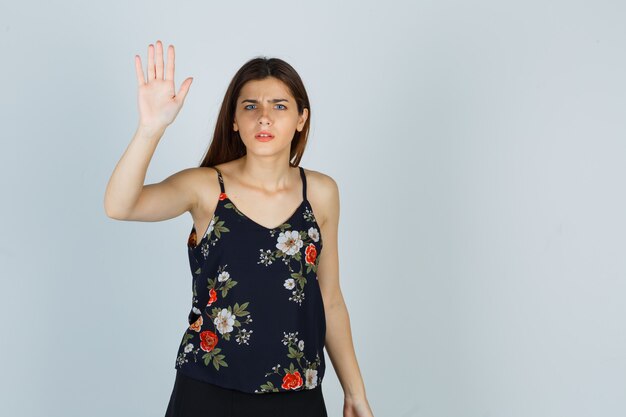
[233,77,309,155]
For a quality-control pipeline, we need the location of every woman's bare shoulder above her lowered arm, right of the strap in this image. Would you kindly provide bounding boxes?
[304,168,339,226]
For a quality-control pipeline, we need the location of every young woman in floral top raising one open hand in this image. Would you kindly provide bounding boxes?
[104,41,373,417]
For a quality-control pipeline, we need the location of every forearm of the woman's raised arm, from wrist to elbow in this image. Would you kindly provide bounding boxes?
[104,125,165,218]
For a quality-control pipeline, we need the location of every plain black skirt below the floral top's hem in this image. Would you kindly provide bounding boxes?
[165,371,328,417]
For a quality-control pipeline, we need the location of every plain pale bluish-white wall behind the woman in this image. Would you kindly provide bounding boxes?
[0,0,626,417]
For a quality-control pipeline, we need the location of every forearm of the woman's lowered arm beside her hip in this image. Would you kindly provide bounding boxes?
[325,297,366,398]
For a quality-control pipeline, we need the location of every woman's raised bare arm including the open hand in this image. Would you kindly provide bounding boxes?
[104,41,196,221]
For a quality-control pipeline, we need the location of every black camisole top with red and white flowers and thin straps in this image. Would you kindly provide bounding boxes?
[175,167,326,394]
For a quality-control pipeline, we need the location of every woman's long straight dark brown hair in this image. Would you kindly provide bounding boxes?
[200,57,311,167]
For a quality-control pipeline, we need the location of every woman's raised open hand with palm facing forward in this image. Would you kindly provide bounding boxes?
[135,40,193,130]
